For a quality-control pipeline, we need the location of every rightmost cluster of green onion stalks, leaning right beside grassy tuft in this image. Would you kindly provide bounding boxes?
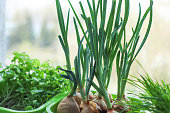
[116,0,153,100]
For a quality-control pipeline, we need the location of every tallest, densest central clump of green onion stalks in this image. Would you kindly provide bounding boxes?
[68,0,129,108]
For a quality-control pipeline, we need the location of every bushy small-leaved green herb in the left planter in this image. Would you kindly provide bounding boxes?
[0,52,69,110]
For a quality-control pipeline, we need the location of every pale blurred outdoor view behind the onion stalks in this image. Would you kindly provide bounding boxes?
[0,0,170,92]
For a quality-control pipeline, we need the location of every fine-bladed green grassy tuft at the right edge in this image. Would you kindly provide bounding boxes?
[129,73,170,113]
